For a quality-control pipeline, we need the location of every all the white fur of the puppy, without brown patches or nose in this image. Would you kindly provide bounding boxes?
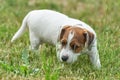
[11,10,101,68]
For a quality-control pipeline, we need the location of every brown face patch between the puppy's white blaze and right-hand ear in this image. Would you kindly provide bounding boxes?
[70,27,86,53]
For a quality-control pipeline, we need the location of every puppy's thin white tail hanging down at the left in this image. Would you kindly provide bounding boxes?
[11,12,29,42]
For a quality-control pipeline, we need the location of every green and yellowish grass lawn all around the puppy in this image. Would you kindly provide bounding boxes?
[0,0,120,80]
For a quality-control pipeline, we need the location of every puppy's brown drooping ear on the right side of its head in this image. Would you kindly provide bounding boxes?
[83,30,94,46]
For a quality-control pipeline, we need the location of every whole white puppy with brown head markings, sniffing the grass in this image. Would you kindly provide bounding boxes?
[11,10,101,68]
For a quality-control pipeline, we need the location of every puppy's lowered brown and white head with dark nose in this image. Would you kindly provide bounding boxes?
[57,25,94,63]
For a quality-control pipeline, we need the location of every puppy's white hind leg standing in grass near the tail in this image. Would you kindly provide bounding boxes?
[29,31,40,50]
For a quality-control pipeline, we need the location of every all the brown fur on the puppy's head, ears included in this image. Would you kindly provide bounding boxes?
[60,25,94,53]
